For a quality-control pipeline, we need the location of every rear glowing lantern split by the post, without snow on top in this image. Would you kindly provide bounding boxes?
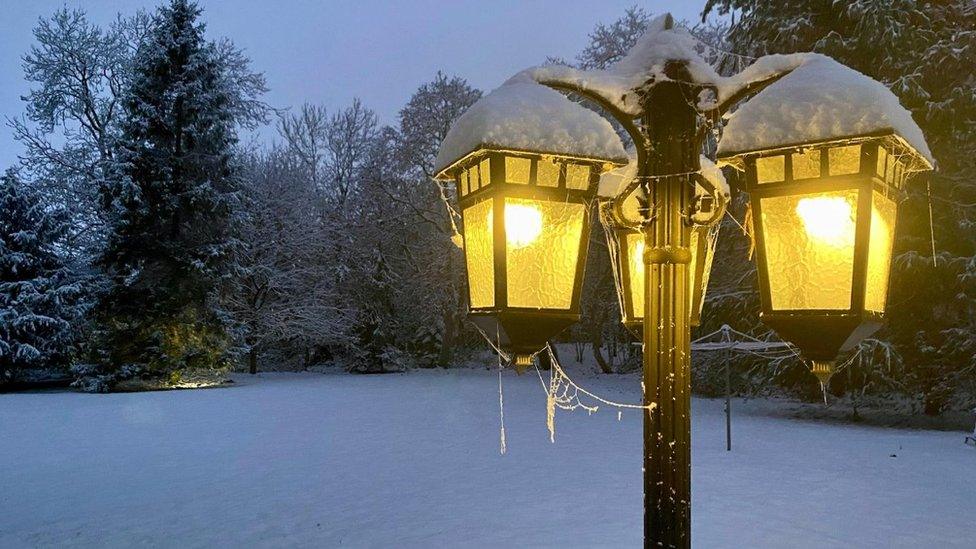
[603,176,725,337]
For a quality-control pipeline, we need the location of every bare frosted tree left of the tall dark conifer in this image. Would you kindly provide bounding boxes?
[8,8,150,264]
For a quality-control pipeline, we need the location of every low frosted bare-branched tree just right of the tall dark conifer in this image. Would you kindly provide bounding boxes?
[224,149,351,374]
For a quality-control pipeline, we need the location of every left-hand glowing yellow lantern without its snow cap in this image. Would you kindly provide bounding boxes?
[437,147,613,368]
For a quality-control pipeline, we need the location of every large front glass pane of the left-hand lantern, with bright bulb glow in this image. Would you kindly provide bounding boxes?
[505,198,586,309]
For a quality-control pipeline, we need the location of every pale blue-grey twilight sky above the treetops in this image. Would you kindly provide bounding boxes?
[0,0,704,170]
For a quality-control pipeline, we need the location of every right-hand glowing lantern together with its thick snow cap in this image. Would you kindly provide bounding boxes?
[719,56,933,383]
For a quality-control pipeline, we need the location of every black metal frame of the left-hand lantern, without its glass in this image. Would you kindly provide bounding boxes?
[438,146,623,368]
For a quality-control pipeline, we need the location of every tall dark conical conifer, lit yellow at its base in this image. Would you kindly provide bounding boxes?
[98,0,242,374]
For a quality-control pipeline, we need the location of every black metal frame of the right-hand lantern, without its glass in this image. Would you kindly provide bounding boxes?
[720,130,932,363]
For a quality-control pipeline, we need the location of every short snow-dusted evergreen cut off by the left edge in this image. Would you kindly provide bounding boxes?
[0,171,81,384]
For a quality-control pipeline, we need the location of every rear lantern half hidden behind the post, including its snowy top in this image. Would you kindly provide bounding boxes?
[601,157,728,336]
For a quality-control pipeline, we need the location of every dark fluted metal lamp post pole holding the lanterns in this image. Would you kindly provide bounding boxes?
[638,62,701,548]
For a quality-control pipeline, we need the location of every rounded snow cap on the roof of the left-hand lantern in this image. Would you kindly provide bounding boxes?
[434,74,627,173]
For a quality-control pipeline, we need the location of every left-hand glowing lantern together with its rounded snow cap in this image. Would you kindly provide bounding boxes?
[435,78,626,370]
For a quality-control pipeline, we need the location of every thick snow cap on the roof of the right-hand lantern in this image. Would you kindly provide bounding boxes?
[718,54,934,168]
